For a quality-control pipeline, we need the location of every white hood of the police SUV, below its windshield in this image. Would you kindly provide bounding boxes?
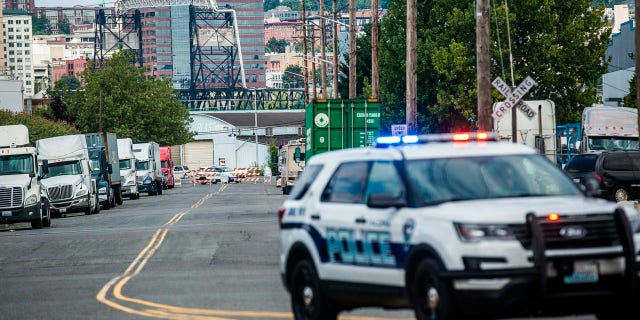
[436,196,634,223]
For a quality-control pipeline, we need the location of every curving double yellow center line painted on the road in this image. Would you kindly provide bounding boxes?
[96,189,410,320]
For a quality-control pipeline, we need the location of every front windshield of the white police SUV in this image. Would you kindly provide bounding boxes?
[406,155,581,205]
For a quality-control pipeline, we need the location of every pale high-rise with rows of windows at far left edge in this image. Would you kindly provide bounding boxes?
[2,10,34,96]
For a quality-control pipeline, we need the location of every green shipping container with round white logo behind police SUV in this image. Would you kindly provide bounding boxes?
[305,99,380,159]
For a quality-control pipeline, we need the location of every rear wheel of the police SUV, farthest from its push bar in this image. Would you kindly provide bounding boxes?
[290,260,338,320]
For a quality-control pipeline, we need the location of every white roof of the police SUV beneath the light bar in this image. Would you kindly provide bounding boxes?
[307,141,538,164]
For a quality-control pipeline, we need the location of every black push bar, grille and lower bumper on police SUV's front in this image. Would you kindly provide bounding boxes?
[440,210,640,317]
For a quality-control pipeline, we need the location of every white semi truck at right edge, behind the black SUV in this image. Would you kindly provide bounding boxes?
[579,105,638,152]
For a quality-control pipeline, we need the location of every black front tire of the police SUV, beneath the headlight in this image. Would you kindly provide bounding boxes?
[409,258,458,320]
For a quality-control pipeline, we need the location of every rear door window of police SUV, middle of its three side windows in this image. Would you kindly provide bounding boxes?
[321,161,369,203]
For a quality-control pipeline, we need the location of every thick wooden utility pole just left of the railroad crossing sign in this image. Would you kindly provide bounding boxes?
[476,0,493,131]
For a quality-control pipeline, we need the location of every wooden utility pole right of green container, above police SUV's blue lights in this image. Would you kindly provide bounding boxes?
[406,0,418,134]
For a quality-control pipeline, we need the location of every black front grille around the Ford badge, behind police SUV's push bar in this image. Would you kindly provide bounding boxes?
[509,214,620,249]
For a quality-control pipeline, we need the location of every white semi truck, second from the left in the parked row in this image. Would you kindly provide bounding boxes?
[36,134,100,217]
